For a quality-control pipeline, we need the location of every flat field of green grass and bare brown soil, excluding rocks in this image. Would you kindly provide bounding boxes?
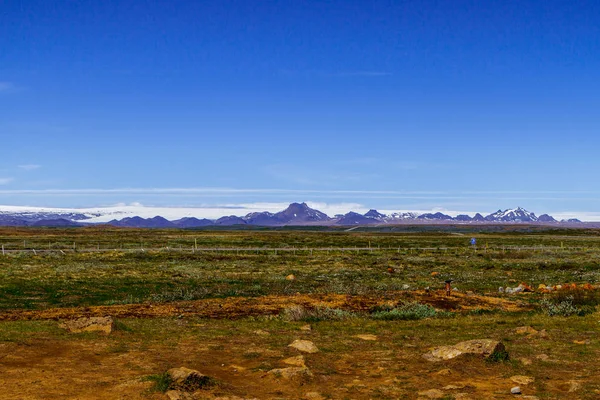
[0,226,600,399]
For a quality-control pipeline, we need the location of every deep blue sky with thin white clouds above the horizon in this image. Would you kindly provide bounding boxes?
[0,0,600,219]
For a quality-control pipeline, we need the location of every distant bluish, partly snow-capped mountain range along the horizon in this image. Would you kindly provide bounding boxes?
[0,203,581,228]
